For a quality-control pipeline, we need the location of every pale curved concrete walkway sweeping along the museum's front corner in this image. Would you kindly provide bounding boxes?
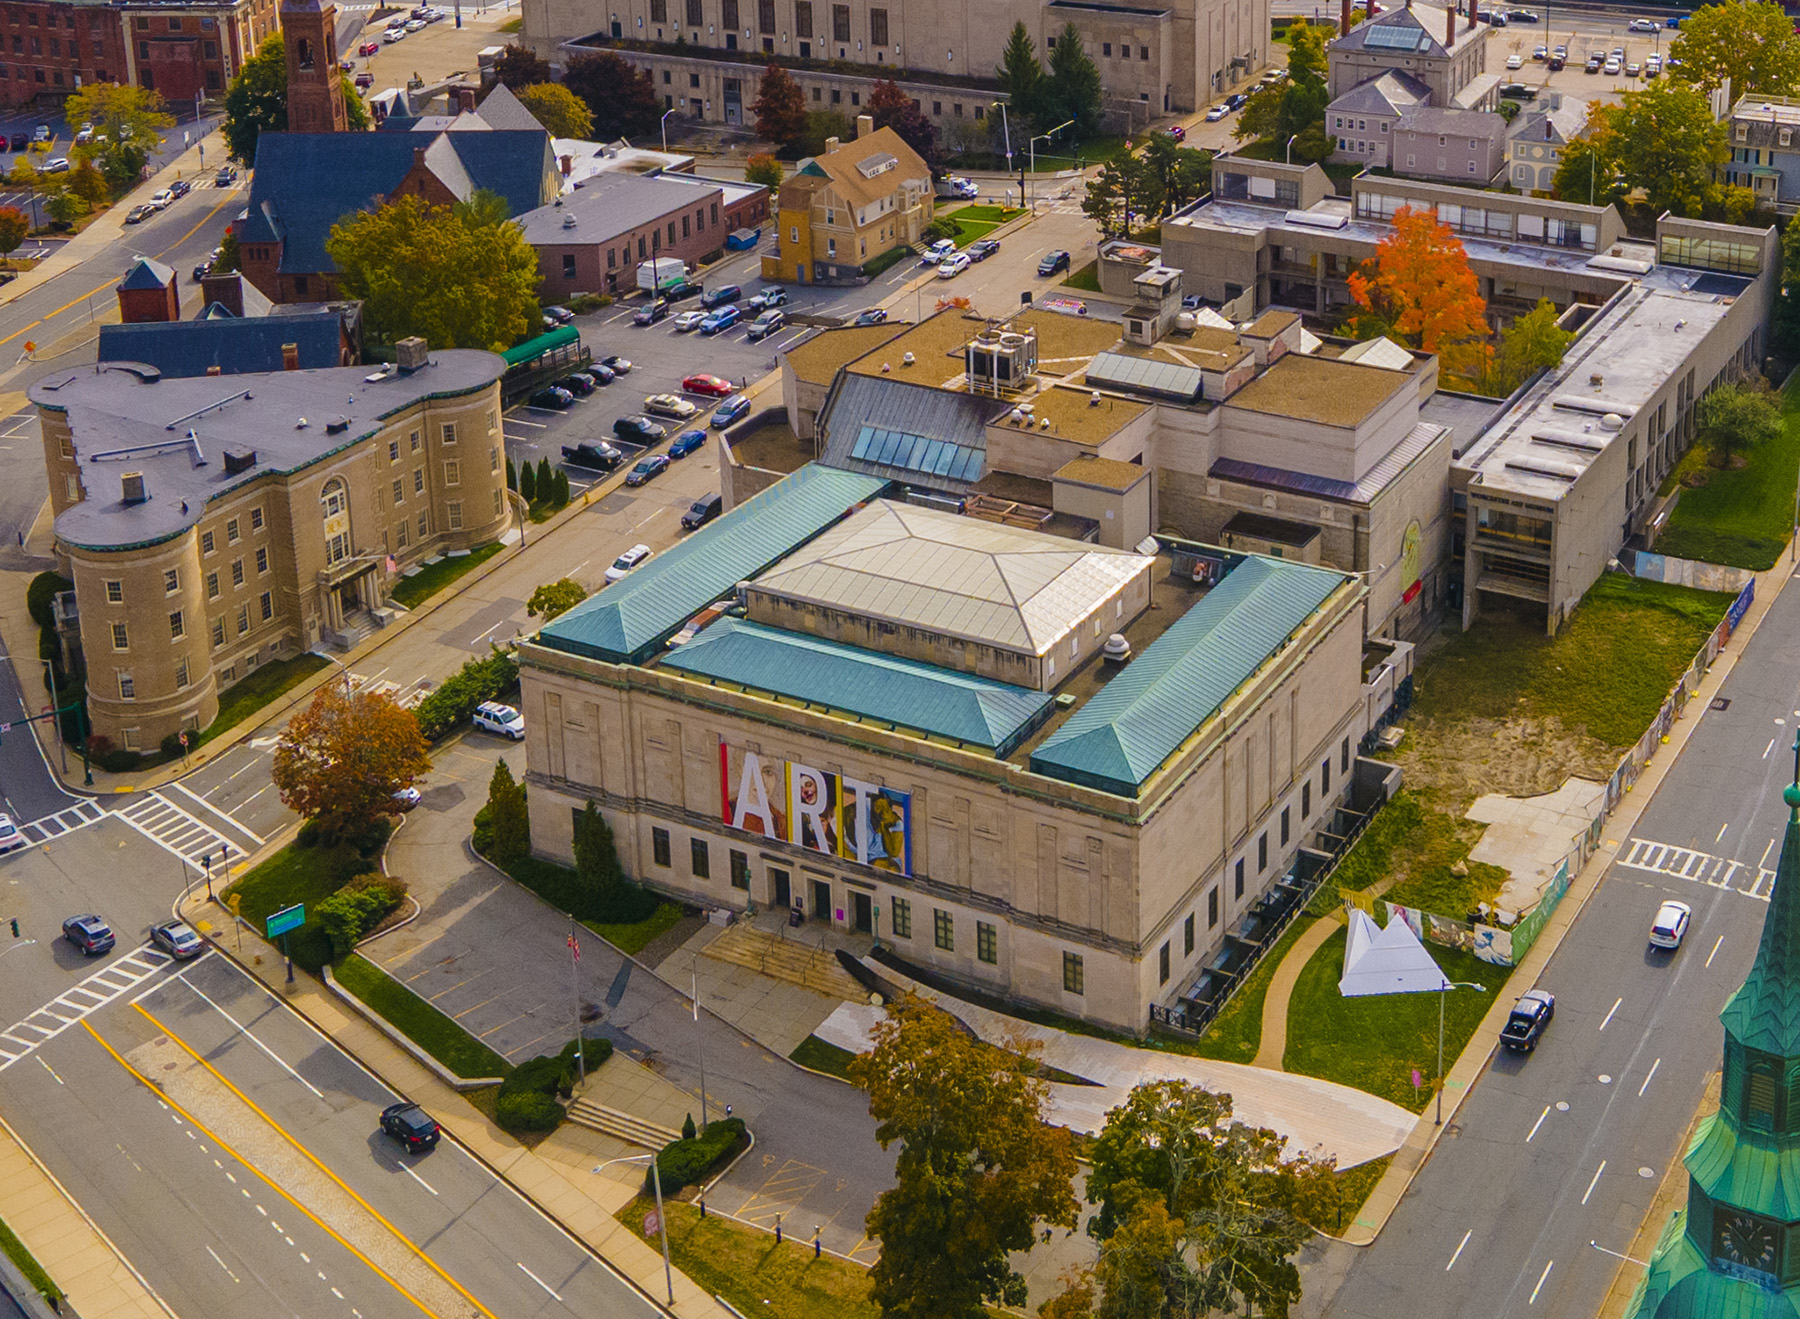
[817,966,1415,1168]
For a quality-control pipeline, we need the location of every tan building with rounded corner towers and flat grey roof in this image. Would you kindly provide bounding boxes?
[27,340,509,750]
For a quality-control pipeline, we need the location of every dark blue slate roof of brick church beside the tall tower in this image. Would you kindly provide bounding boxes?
[241,128,562,274]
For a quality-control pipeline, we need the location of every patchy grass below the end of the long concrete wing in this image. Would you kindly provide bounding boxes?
[1413,572,1732,750]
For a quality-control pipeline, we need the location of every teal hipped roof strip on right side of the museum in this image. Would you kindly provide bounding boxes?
[1031,558,1346,797]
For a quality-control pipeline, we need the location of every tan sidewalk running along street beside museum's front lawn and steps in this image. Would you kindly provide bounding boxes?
[179,894,731,1319]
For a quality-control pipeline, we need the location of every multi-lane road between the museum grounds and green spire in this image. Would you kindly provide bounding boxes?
[1309,572,1800,1319]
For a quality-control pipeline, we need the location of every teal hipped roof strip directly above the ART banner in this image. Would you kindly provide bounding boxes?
[661,617,1055,756]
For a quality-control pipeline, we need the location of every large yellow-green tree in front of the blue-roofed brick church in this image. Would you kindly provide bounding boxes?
[326,193,538,353]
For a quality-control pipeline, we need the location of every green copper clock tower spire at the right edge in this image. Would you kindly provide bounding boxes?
[1627,736,1800,1319]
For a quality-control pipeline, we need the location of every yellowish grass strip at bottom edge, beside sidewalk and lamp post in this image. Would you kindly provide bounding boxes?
[617,1195,880,1319]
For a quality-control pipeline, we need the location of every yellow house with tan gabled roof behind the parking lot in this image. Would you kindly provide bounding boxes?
[763,115,932,284]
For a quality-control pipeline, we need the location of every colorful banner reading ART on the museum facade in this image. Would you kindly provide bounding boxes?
[718,740,913,875]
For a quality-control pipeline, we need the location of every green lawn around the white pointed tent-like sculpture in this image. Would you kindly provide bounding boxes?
[1282,930,1512,1112]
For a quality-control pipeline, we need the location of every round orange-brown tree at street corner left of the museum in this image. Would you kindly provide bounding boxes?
[270,682,432,839]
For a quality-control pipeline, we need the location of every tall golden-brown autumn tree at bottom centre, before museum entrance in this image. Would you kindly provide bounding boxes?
[850,997,1076,1319]
